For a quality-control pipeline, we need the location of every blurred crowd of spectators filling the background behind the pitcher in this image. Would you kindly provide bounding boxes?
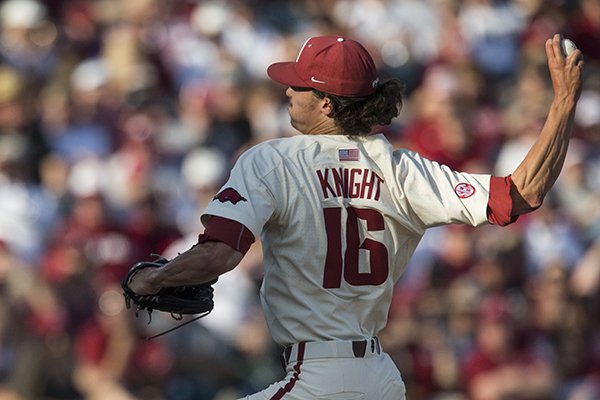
[0,0,600,400]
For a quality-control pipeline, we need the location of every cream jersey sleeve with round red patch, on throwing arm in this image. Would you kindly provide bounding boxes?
[396,151,491,231]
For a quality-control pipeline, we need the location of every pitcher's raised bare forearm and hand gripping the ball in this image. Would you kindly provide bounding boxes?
[511,34,583,216]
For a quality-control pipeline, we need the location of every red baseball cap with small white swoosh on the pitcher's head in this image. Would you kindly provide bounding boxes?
[267,36,379,97]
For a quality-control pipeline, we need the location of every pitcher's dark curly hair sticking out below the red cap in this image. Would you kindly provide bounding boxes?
[313,79,405,136]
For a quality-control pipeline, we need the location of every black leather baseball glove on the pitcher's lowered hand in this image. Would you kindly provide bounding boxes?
[121,256,217,337]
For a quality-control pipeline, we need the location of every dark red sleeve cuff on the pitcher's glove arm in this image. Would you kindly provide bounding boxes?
[198,215,254,254]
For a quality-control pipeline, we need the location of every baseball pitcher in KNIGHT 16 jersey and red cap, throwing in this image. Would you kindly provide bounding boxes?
[129,35,583,400]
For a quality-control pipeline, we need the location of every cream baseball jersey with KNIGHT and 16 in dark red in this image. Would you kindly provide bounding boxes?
[205,135,490,346]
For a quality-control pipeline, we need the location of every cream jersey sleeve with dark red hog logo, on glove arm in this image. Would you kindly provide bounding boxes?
[202,149,276,237]
